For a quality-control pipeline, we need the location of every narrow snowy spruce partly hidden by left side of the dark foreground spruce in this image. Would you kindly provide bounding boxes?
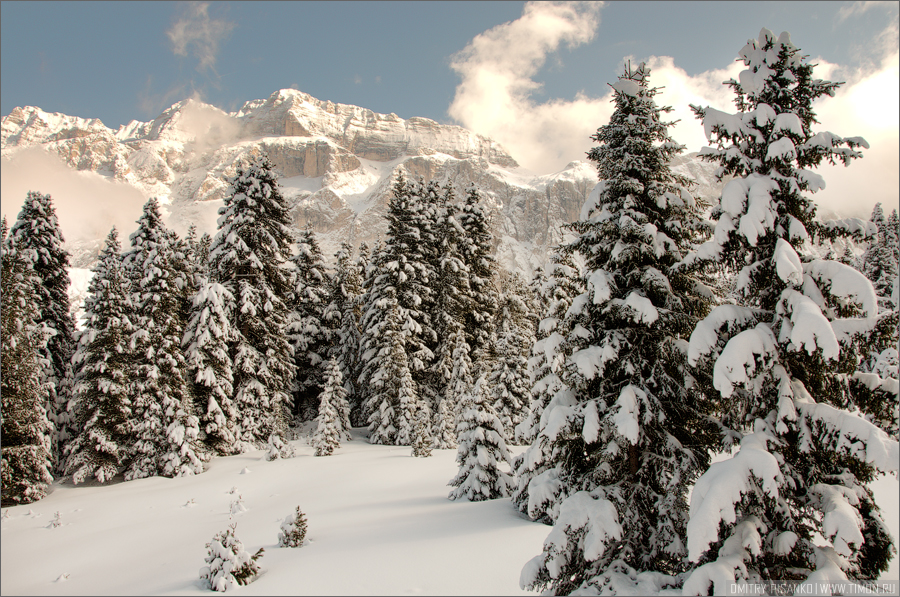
[512,246,585,524]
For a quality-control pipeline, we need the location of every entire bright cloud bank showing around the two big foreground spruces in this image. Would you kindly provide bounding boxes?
[449,3,900,217]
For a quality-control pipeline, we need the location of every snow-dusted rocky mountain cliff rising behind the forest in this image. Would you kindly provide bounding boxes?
[0,89,717,274]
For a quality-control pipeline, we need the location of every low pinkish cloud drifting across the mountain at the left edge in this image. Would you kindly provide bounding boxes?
[0,147,146,245]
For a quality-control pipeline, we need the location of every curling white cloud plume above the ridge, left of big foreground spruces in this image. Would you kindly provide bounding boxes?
[448,2,612,172]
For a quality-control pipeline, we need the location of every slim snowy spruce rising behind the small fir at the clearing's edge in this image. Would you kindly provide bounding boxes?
[487,273,534,445]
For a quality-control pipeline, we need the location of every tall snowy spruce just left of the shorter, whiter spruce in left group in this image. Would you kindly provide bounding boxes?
[122,197,208,480]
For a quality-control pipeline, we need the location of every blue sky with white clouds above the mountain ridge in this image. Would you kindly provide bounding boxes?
[0,1,900,216]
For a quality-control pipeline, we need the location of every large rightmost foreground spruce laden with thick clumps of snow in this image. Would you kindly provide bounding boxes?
[683,29,900,595]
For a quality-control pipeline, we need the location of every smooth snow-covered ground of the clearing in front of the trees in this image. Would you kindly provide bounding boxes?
[0,429,900,595]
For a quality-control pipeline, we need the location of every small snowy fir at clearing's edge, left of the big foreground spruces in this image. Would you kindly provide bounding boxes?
[447,376,513,502]
